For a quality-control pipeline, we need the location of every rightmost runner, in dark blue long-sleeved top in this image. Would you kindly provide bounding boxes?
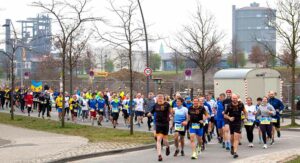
[268,91,284,144]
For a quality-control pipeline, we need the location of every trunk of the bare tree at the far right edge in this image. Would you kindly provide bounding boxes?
[291,56,296,126]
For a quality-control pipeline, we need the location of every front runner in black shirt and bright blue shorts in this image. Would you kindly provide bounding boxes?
[188,98,208,159]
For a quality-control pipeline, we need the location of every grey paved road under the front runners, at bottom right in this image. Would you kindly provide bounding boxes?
[76,131,300,163]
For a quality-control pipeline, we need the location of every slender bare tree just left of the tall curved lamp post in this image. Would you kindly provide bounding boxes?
[96,0,144,134]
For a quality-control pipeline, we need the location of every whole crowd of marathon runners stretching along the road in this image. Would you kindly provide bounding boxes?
[0,88,284,161]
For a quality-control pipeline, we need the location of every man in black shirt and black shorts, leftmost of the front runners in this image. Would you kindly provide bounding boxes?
[148,93,171,161]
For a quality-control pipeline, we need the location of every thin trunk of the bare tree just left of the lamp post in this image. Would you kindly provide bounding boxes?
[128,45,134,135]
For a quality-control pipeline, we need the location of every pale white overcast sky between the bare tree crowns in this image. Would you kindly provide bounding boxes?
[0,0,275,51]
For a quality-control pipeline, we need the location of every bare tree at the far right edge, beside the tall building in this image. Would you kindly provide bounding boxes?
[268,0,300,125]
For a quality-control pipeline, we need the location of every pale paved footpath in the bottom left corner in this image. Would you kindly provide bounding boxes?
[0,124,88,162]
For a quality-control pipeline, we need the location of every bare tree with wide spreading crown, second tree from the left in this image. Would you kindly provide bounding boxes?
[32,0,102,127]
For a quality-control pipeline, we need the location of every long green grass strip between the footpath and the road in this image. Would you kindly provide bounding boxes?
[0,113,154,144]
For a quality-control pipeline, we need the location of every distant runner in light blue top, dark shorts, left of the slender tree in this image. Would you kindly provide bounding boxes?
[110,94,121,128]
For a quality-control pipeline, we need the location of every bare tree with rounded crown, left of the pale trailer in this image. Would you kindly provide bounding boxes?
[171,5,224,94]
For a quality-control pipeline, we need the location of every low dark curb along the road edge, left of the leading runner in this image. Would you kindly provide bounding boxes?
[49,141,174,163]
